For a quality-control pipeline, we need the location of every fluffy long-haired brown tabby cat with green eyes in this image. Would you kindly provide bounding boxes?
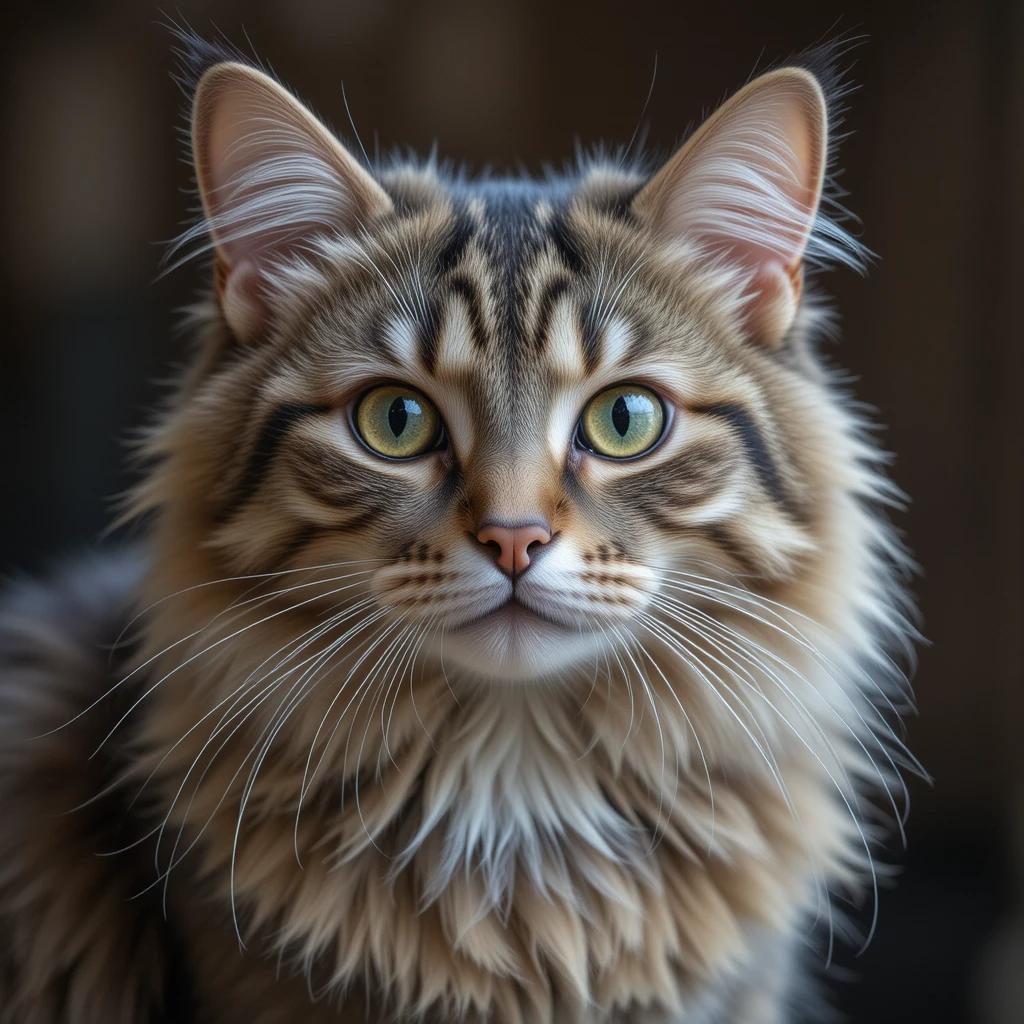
[0,32,915,1024]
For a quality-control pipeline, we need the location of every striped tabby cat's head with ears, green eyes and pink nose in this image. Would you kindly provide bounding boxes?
[151,49,859,680]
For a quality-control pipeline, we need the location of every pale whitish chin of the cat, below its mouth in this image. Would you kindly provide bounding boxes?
[439,605,600,682]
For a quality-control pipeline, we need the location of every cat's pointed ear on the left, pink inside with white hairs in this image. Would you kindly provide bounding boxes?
[191,62,391,340]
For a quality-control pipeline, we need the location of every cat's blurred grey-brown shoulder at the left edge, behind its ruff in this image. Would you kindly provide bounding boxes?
[0,551,192,1024]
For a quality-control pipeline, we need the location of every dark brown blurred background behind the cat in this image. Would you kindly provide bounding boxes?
[0,0,1024,1024]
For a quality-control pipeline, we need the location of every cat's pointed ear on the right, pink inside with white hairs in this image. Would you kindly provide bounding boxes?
[634,68,828,346]
